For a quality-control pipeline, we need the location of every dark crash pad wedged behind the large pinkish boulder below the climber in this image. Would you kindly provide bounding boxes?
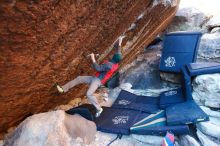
[66,104,96,121]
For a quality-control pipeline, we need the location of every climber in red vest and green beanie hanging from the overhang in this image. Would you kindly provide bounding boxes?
[56,36,124,117]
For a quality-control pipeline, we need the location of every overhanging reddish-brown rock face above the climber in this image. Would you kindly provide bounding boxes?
[0,0,179,133]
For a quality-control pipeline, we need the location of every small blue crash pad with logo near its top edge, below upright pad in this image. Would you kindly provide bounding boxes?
[160,88,185,109]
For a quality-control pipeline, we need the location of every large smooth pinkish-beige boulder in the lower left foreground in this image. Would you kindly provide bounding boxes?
[4,110,96,146]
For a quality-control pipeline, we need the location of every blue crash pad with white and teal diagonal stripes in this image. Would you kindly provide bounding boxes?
[130,110,189,135]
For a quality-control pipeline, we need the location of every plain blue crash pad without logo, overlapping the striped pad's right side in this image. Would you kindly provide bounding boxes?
[166,100,209,125]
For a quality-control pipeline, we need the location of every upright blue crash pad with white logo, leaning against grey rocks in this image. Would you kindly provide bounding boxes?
[159,32,202,73]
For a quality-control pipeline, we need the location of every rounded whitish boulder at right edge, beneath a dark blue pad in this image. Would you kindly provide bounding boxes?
[192,73,220,108]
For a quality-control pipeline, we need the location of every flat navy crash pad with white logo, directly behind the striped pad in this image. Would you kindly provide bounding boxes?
[112,90,159,113]
